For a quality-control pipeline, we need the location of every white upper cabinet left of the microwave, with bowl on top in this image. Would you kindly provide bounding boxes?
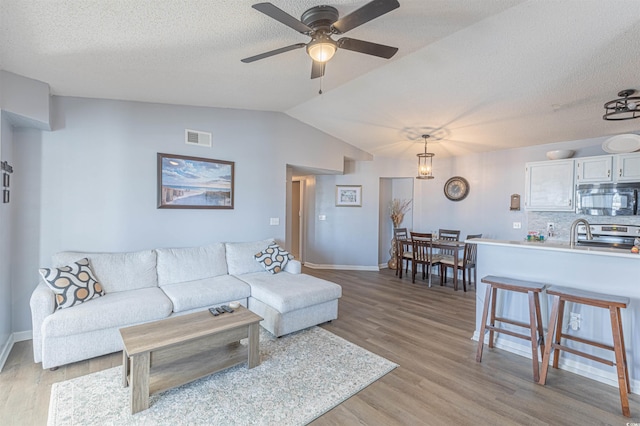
[524,159,575,211]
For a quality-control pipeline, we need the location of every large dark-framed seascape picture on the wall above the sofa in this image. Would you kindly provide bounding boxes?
[157,153,235,209]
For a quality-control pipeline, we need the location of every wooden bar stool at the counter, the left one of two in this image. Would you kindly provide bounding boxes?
[476,275,546,382]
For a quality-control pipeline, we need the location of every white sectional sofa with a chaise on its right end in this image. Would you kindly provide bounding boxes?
[30,240,342,368]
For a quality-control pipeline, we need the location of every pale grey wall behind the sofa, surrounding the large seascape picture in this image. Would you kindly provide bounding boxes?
[12,97,375,331]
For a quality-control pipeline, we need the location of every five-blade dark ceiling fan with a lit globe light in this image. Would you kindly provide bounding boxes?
[242,0,400,78]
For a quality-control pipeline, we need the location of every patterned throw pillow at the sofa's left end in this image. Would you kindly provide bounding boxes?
[38,258,105,309]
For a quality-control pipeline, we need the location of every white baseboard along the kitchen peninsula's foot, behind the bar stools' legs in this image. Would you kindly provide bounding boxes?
[471,330,640,394]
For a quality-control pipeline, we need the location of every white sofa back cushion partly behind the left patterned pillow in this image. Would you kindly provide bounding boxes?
[51,250,158,294]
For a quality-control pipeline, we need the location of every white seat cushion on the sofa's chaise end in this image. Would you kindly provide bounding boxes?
[238,271,342,313]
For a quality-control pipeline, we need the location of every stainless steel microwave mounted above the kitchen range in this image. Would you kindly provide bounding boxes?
[576,183,640,216]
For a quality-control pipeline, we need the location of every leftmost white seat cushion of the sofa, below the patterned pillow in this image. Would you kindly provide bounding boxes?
[42,287,173,337]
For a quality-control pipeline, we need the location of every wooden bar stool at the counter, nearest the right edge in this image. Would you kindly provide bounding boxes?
[539,286,631,417]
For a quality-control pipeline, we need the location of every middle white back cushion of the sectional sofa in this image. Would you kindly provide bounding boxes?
[156,243,227,286]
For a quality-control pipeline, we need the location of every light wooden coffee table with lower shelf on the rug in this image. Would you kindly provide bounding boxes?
[120,307,262,414]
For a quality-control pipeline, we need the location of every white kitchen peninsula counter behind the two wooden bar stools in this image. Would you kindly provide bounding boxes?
[473,238,640,393]
